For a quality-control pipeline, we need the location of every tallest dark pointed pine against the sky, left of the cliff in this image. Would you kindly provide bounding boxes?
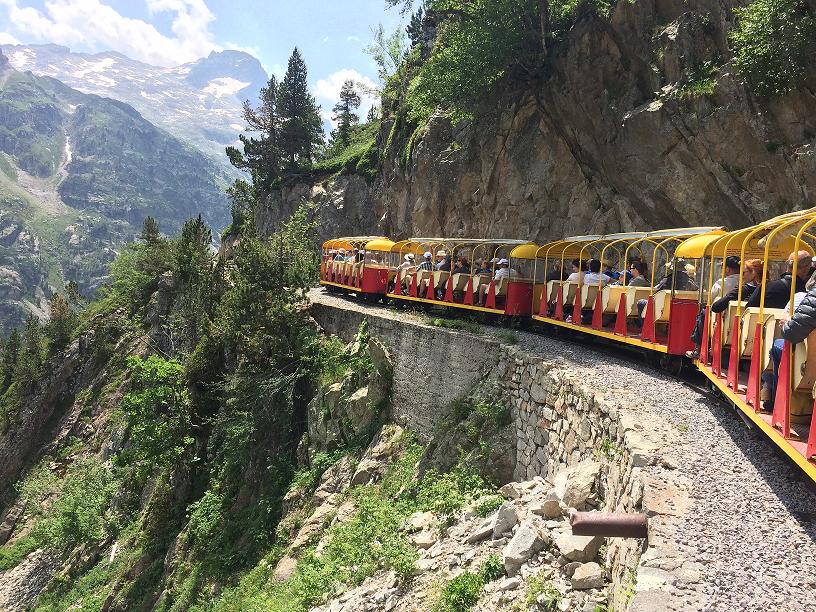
[277,47,323,170]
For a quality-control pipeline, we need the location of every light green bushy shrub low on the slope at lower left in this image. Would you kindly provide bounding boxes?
[18,457,119,550]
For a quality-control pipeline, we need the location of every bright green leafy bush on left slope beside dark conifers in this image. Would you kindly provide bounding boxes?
[116,355,194,480]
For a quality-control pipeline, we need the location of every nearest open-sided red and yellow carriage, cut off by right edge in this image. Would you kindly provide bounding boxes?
[692,209,816,480]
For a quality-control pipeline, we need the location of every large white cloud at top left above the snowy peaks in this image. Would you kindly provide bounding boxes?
[0,0,220,66]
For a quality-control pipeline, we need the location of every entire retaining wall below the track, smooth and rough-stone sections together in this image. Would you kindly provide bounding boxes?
[312,296,677,610]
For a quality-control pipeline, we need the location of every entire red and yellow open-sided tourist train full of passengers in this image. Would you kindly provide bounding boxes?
[320,209,816,488]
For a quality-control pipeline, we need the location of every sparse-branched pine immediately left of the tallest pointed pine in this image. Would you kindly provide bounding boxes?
[227,76,282,189]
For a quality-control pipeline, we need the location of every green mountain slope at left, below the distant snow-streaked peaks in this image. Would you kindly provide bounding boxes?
[0,55,229,331]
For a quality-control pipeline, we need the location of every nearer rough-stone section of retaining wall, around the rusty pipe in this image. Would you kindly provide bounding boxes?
[498,347,660,609]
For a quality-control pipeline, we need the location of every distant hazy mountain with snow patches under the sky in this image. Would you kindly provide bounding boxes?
[4,45,268,163]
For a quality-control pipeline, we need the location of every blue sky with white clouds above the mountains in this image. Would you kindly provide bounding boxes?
[0,0,406,115]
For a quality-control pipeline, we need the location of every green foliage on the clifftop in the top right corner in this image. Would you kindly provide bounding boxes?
[729,0,816,96]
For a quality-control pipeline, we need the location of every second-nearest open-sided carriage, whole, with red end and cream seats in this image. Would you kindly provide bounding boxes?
[532,227,723,355]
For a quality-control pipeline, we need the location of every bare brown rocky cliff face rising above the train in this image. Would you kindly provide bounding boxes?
[261,0,816,241]
